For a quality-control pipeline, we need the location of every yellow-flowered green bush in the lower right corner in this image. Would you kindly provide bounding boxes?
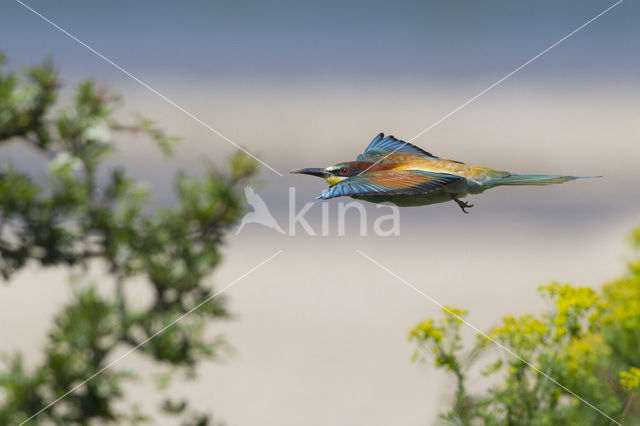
[409,228,640,425]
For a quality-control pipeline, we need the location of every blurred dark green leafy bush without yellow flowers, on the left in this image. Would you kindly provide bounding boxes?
[0,53,256,425]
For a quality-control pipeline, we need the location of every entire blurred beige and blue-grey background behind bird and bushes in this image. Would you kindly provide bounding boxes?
[0,0,640,426]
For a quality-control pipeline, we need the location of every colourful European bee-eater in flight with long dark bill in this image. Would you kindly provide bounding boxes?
[291,133,586,213]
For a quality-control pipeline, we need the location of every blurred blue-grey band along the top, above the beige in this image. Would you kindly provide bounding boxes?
[0,0,640,82]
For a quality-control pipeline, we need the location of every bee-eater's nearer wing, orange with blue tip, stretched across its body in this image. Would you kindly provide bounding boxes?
[316,170,464,200]
